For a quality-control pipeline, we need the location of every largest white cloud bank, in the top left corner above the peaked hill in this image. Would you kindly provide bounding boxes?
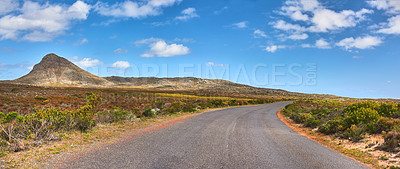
[0,0,91,42]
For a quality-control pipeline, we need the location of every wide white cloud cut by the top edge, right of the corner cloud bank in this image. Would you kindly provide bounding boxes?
[95,0,182,18]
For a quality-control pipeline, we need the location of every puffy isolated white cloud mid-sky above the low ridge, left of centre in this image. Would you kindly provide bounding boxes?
[141,39,190,57]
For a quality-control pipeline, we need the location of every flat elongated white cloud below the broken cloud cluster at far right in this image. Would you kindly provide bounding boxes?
[336,36,383,50]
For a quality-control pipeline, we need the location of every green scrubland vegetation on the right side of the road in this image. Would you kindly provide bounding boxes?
[282,99,400,152]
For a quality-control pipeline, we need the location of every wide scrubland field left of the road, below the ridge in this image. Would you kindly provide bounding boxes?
[0,85,289,155]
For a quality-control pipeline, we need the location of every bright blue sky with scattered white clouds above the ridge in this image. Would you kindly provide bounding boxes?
[0,0,400,98]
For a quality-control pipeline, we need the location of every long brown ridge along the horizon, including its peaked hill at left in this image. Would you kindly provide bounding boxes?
[10,53,322,97]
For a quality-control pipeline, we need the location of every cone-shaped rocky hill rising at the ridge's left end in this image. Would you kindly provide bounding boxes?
[13,53,113,86]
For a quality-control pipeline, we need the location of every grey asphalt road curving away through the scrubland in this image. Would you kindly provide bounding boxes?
[63,102,367,169]
